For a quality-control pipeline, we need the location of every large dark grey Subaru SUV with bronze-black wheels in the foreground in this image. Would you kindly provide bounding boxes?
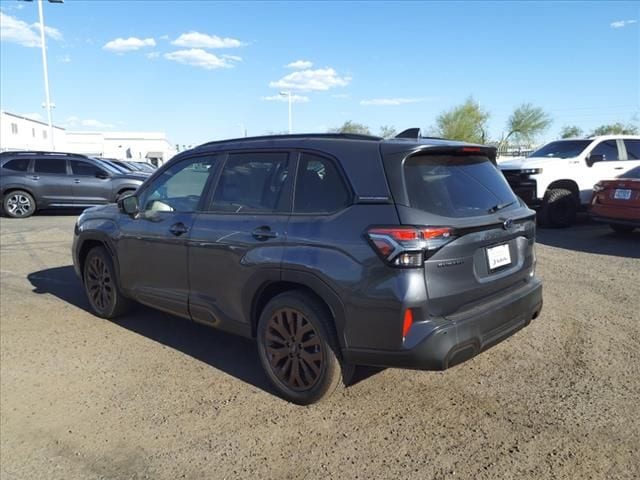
[73,134,542,404]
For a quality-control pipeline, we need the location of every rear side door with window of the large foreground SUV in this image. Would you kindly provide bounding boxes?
[189,151,292,335]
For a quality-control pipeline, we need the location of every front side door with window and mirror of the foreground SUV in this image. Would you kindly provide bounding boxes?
[117,155,216,318]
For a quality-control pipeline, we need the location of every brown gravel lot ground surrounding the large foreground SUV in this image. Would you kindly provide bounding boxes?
[0,215,640,480]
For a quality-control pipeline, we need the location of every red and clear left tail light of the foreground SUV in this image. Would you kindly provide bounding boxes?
[367,227,455,267]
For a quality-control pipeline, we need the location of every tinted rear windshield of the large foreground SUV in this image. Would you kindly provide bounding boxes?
[404,155,518,217]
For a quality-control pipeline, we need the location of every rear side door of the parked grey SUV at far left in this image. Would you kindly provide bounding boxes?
[28,157,73,206]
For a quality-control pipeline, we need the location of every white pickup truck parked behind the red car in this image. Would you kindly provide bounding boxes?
[499,135,640,227]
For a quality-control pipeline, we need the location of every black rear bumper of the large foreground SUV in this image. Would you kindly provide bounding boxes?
[343,278,542,370]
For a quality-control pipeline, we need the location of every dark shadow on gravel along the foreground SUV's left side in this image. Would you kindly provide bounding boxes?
[27,265,275,395]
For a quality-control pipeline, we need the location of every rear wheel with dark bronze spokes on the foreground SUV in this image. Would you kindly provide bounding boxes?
[257,291,342,405]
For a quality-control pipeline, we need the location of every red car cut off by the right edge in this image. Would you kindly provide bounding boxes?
[589,167,640,233]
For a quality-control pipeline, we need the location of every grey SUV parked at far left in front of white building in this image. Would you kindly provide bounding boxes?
[0,152,148,218]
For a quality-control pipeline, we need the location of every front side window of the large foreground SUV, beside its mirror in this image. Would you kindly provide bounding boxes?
[139,156,215,213]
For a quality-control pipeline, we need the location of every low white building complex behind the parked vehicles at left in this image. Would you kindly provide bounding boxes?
[0,112,177,165]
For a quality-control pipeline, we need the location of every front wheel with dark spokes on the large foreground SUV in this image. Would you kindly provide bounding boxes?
[82,247,131,319]
